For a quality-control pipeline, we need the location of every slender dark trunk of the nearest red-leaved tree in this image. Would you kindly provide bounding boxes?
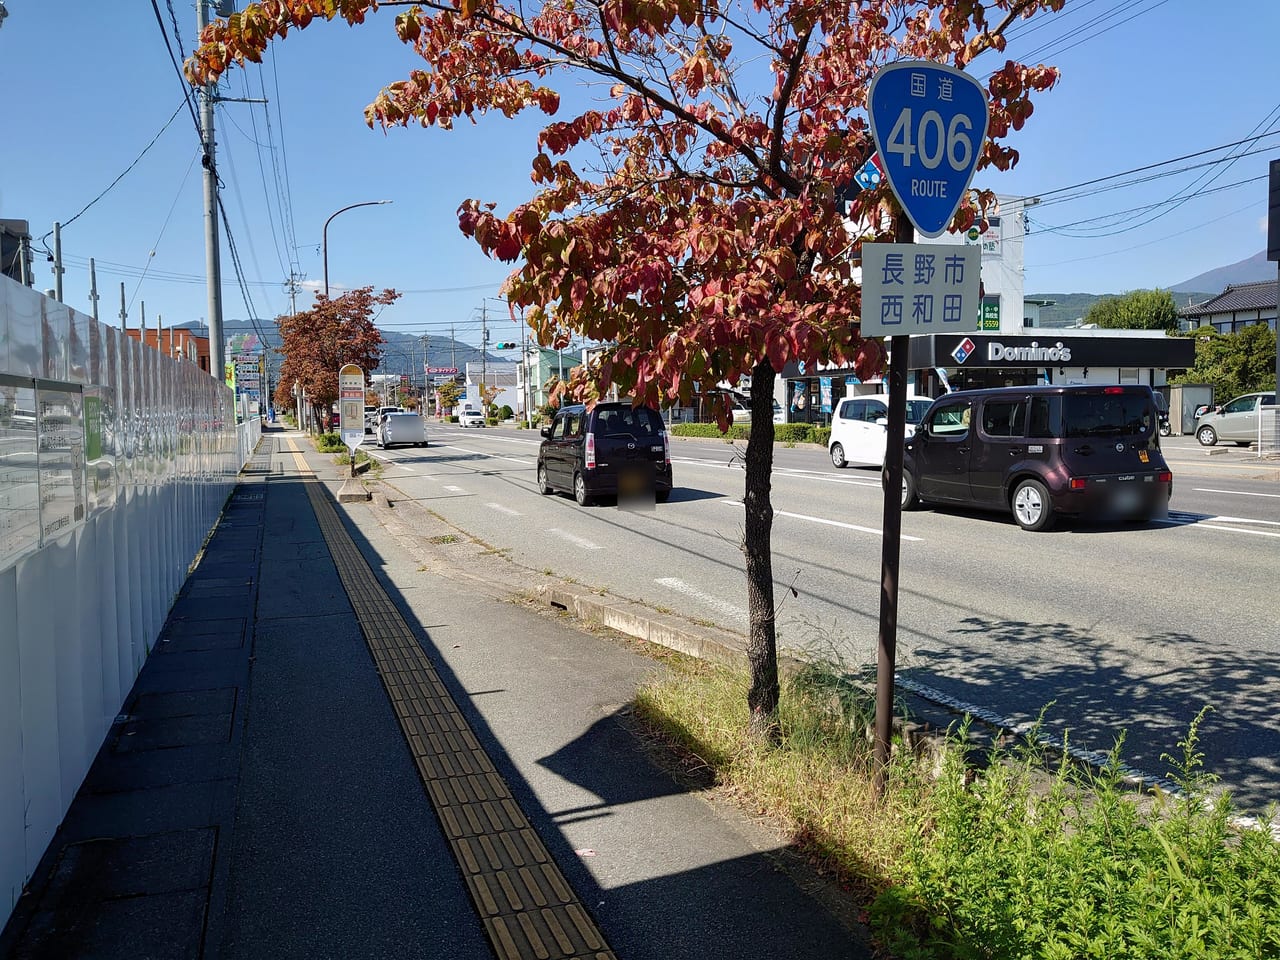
[742,360,778,739]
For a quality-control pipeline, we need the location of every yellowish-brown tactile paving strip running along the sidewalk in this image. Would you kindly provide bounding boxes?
[287,439,616,960]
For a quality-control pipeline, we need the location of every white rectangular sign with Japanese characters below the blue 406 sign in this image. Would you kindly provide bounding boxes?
[863,243,982,337]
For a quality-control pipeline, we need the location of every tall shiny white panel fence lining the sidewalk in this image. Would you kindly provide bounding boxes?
[0,276,244,924]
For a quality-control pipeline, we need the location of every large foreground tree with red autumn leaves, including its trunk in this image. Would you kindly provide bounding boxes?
[187,0,1064,732]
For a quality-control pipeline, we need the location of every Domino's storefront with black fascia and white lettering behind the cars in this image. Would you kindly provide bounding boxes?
[782,329,1196,424]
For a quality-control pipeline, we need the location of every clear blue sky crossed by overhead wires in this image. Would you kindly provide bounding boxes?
[0,0,1280,360]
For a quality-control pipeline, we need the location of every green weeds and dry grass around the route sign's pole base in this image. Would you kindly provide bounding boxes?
[636,662,1280,960]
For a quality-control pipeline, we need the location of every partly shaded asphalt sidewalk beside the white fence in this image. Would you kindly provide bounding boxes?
[0,430,869,960]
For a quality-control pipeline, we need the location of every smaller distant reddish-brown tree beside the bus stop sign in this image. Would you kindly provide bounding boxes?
[275,287,401,428]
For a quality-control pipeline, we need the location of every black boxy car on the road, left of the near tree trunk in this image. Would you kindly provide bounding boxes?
[538,401,672,507]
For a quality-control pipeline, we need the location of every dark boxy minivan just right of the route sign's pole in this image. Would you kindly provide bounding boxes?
[902,385,1174,530]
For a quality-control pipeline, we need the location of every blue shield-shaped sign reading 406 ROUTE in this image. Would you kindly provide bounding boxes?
[869,60,987,237]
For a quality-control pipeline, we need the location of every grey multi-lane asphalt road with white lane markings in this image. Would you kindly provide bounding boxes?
[363,426,1280,806]
